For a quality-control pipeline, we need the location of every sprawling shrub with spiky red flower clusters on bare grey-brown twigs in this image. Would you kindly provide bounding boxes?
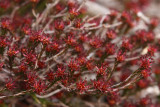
[0,0,160,107]
